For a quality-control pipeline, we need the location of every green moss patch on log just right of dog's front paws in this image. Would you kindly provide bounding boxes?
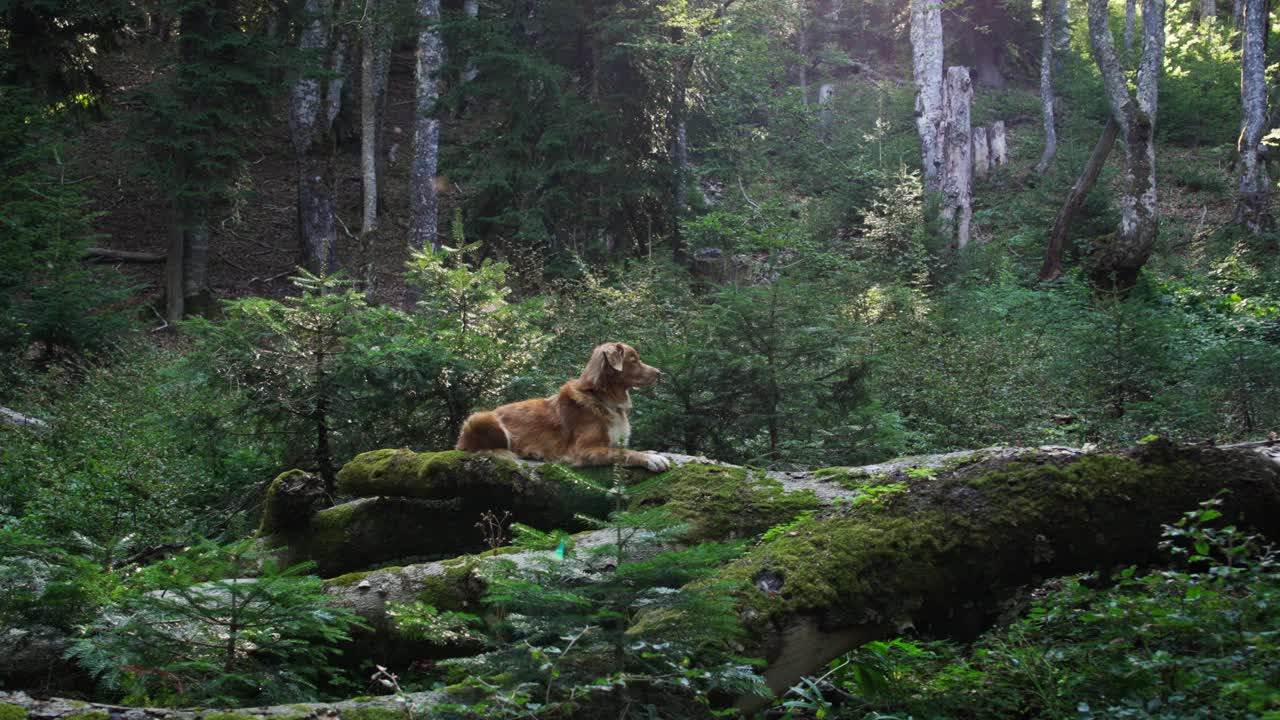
[637,465,820,542]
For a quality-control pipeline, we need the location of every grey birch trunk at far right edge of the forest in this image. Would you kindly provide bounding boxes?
[1236,0,1272,229]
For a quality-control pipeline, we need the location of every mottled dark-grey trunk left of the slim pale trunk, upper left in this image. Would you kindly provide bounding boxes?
[289,0,346,273]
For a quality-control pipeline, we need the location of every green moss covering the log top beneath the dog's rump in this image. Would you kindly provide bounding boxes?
[338,450,522,498]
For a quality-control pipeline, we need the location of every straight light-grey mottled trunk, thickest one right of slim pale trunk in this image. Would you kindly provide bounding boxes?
[408,0,442,250]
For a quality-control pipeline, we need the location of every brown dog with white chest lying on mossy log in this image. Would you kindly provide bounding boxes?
[457,342,671,471]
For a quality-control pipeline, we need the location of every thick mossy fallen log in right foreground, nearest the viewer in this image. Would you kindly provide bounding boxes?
[721,441,1280,708]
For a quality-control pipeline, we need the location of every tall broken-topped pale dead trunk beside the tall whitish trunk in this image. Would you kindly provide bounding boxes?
[941,67,973,249]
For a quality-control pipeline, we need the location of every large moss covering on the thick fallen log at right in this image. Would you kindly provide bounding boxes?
[721,440,1258,624]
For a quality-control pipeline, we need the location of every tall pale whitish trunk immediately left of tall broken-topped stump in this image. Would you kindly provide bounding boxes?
[911,0,942,195]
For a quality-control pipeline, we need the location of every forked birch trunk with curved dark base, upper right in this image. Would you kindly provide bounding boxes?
[1088,0,1165,292]
